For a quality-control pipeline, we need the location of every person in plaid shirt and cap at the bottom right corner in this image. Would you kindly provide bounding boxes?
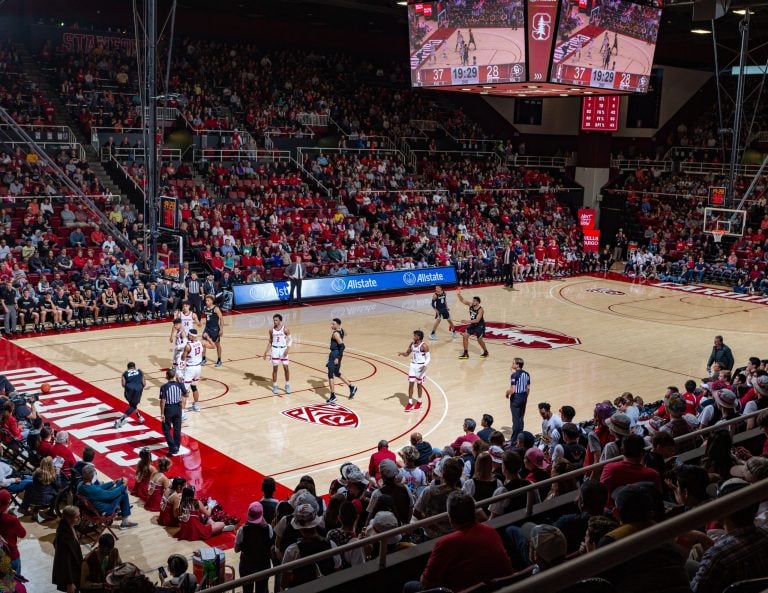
[691,478,768,593]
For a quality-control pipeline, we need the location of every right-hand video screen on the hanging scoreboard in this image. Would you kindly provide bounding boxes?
[550,0,661,93]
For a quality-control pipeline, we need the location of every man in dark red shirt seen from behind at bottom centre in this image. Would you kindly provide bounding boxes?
[403,491,512,593]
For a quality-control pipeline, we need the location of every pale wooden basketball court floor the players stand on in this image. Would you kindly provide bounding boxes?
[16,276,768,592]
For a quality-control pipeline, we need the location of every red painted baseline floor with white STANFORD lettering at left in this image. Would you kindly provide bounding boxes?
[0,339,290,547]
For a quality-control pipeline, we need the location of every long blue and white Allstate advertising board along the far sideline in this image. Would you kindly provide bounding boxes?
[233,267,456,307]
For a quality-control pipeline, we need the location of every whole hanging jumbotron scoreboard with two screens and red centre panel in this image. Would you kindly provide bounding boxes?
[408,0,662,97]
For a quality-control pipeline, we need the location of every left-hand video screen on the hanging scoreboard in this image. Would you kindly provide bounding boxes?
[408,0,526,87]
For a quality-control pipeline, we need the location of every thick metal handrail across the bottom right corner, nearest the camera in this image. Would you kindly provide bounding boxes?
[498,480,768,593]
